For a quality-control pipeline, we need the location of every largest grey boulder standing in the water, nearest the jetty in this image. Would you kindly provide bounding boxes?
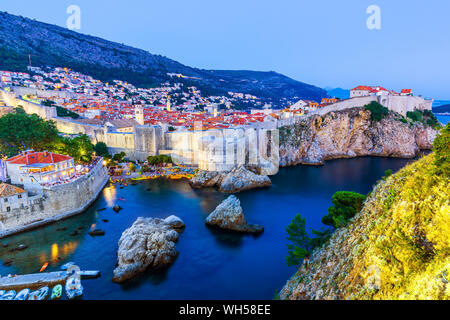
[113,216,184,282]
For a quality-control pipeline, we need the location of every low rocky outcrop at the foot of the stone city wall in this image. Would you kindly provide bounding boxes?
[190,166,272,193]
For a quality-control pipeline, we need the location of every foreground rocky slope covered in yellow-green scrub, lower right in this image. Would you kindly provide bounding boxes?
[280,154,450,300]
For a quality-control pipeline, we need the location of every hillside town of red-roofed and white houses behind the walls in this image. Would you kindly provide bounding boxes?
[0,67,422,132]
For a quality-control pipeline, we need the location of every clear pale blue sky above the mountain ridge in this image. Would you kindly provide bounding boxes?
[0,0,450,99]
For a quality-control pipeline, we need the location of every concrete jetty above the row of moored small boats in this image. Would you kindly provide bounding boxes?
[0,271,100,291]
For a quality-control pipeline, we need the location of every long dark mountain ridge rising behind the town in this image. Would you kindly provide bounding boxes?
[0,12,327,104]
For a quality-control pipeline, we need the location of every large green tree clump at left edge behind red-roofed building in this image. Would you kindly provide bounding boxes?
[0,108,60,156]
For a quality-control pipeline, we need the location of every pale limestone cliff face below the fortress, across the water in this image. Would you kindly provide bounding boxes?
[280,108,437,166]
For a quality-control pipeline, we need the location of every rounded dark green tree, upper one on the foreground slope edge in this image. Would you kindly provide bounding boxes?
[322,191,366,229]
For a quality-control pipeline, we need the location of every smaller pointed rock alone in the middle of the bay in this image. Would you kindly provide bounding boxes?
[206,195,264,233]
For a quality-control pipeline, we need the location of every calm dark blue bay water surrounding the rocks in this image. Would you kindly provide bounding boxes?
[0,158,409,299]
